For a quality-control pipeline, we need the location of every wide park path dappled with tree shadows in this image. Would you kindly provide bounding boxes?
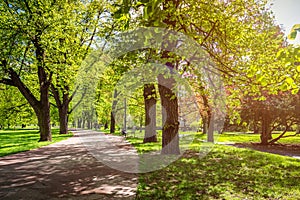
[0,130,138,200]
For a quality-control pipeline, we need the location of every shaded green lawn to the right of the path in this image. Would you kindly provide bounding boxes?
[128,133,300,199]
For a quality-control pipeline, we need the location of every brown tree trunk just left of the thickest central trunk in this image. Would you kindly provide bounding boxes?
[143,84,157,143]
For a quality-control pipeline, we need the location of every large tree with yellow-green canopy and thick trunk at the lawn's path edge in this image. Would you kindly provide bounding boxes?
[116,0,287,154]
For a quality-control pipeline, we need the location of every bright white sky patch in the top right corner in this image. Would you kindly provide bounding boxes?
[269,0,300,44]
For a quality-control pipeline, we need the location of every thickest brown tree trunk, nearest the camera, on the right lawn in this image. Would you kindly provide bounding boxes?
[158,75,180,154]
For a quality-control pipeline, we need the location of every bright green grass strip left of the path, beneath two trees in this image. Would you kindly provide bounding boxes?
[0,129,73,157]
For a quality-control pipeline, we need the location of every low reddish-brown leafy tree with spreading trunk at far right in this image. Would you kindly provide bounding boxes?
[241,91,300,145]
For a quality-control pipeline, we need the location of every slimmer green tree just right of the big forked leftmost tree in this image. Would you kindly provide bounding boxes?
[51,0,111,134]
